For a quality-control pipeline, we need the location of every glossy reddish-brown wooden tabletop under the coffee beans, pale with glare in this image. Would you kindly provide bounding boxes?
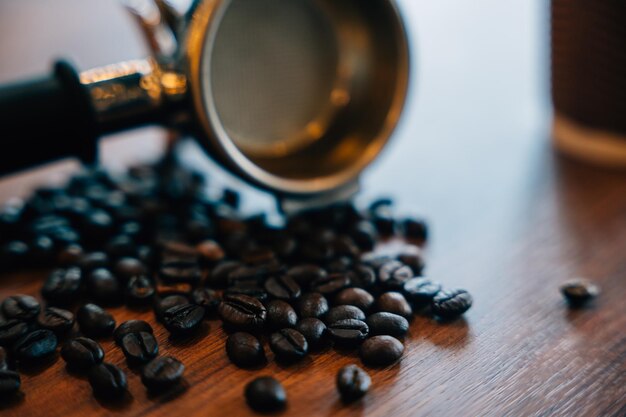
[0,0,626,417]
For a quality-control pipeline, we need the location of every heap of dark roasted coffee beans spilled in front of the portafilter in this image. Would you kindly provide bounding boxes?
[0,153,472,411]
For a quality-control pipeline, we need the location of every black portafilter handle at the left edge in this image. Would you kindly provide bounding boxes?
[0,61,98,175]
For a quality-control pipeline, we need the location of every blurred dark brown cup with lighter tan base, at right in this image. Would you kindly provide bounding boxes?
[551,0,626,168]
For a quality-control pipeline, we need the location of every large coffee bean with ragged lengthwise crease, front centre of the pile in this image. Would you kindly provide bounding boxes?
[218,294,267,330]
